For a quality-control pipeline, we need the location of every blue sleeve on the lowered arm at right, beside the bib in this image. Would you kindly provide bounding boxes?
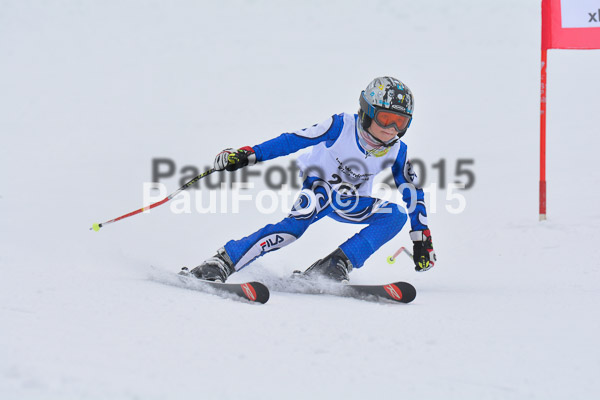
[392,143,429,231]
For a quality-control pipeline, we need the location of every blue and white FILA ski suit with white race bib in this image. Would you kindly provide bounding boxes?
[224,113,428,270]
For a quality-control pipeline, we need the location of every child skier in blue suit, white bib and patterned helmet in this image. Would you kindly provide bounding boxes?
[191,77,436,282]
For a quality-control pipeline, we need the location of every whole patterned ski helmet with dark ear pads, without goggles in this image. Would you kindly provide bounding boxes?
[358,76,415,138]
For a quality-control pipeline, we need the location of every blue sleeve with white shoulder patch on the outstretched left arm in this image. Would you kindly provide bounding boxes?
[252,114,344,161]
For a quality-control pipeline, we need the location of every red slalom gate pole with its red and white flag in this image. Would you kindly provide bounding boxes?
[540,0,600,221]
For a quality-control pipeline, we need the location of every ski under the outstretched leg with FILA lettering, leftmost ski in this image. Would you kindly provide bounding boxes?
[178,268,269,304]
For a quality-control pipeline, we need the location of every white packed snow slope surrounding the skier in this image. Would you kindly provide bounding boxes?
[0,0,600,399]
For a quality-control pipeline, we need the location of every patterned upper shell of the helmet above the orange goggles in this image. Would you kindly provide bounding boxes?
[363,76,415,116]
